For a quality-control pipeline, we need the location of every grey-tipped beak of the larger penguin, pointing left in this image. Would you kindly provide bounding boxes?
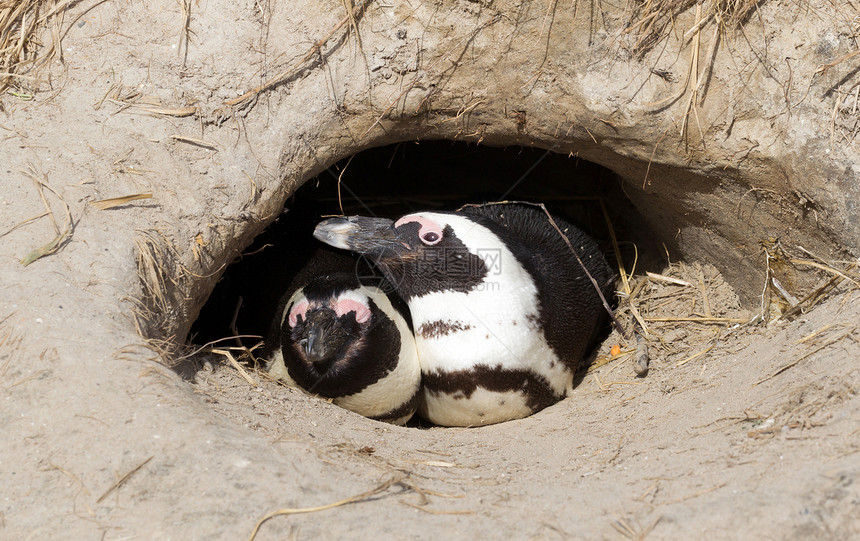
[314,216,409,259]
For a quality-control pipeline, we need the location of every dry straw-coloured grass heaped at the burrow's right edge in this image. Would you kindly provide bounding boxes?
[588,236,860,380]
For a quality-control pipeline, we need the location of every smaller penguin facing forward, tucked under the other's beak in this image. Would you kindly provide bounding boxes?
[267,272,421,424]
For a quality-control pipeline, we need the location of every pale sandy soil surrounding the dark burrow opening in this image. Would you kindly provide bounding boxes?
[0,0,860,540]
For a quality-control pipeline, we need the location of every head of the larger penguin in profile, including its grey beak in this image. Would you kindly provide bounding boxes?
[314,212,490,301]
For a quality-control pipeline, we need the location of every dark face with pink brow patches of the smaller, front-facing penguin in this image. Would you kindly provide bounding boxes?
[284,287,372,373]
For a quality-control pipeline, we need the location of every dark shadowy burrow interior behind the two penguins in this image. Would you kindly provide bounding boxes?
[188,141,672,364]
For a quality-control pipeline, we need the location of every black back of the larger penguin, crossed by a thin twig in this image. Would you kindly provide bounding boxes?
[459,203,615,369]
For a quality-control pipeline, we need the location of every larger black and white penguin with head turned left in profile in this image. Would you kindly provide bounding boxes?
[314,204,614,426]
